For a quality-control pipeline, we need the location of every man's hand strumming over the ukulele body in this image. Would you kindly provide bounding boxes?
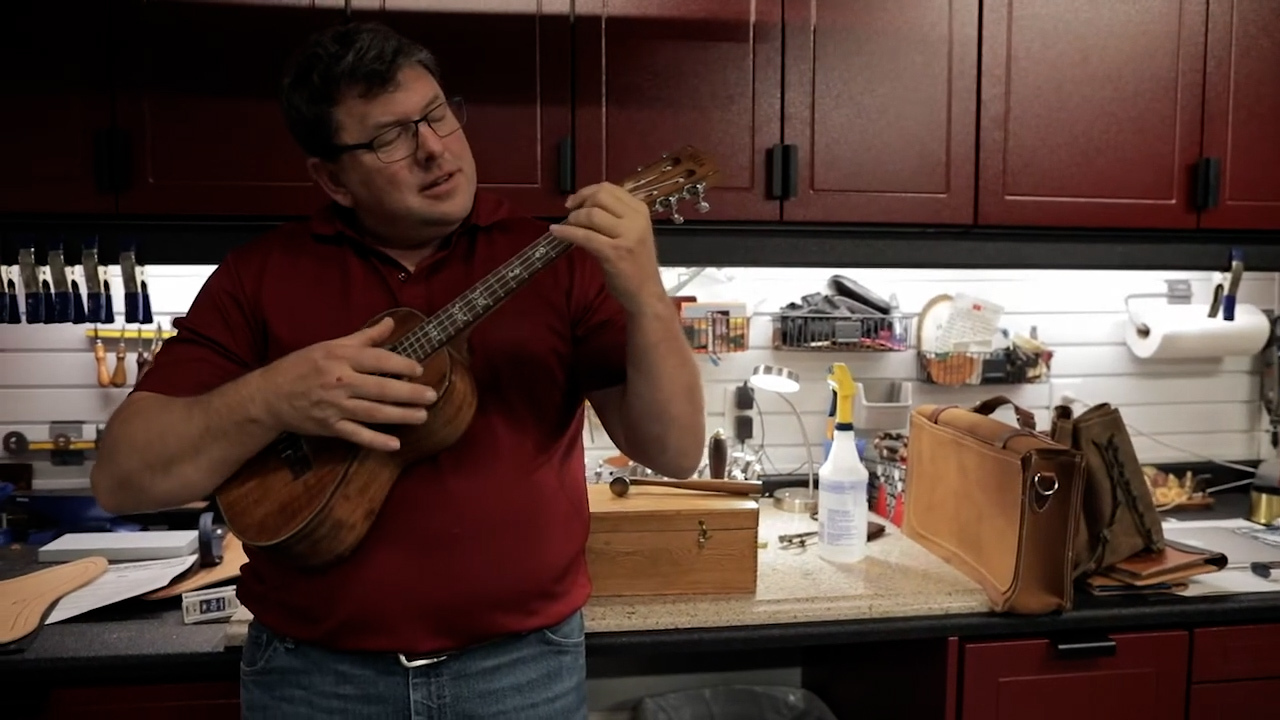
[259,318,436,452]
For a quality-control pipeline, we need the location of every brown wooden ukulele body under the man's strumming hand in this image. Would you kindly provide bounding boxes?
[215,307,476,568]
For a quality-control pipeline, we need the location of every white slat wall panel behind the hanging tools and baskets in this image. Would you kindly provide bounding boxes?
[0,260,1277,477]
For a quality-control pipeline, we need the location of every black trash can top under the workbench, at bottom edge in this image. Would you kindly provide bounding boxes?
[632,685,837,720]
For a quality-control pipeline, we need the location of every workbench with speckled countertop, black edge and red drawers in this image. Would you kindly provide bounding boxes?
[0,486,1280,720]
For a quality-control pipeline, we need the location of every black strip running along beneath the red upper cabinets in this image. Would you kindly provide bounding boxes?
[0,217,1280,272]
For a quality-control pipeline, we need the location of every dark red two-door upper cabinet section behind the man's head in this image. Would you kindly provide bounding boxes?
[110,0,572,215]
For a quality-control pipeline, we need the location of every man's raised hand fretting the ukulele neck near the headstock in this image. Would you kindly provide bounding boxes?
[550,182,667,309]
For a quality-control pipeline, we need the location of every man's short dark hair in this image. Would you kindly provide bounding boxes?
[280,22,440,159]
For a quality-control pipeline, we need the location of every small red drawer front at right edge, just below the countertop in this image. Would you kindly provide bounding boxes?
[1192,624,1280,683]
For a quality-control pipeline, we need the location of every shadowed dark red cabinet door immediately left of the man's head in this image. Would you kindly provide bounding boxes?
[115,0,342,215]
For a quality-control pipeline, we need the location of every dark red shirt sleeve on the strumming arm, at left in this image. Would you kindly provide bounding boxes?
[133,254,264,397]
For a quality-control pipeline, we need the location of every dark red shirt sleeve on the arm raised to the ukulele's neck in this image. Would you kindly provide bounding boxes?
[570,249,627,393]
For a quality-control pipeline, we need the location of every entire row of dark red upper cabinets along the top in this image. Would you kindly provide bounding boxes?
[0,0,1280,229]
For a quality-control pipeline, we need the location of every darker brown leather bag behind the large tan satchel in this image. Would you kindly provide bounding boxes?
[1048,402,1165,578]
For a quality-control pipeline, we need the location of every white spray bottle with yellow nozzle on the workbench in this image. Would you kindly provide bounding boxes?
[818,363,869,562]
